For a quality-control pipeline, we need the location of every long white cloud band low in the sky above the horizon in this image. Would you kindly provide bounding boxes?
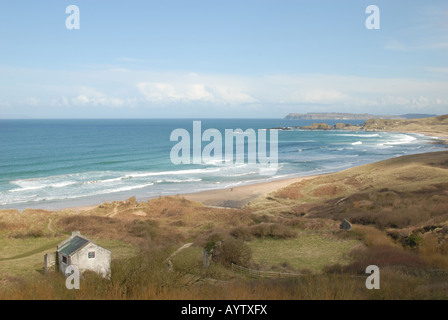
[0,67,448,117]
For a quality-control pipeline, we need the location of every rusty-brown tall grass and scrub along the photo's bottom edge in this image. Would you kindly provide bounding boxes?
[0,245,448,300]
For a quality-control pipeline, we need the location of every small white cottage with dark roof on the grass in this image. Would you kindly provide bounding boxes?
[56,231,111,277]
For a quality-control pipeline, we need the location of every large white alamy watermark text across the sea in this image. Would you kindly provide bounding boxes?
[170,121,278,175]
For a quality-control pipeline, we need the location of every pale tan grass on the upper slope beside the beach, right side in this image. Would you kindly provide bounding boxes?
[272,151,448,202]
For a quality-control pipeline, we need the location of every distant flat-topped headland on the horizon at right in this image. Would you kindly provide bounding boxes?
[285,112,436,120]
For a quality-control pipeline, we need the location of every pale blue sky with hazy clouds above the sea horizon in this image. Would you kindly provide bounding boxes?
[0,0,448,119]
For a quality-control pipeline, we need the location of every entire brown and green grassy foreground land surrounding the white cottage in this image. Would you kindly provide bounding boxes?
[0,151,448,300]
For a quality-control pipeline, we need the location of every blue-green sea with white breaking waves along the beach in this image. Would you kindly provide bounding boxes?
[0,119,446,210]
